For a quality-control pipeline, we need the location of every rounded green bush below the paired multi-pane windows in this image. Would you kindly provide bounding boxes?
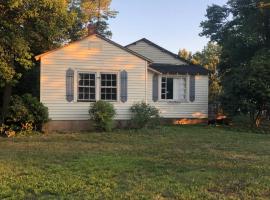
[89,101,116,131]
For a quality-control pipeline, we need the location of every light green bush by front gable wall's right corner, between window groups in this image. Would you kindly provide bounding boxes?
[130,102,160,128]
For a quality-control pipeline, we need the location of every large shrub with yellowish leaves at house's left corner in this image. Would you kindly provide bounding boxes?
[5,94,49,132]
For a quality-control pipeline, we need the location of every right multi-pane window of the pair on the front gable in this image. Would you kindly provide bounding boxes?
[100,73,117,101]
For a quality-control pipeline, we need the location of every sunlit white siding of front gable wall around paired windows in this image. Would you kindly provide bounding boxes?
[40,36,147,120]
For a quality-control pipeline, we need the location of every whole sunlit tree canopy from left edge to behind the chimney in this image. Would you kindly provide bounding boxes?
[0,0,117,121]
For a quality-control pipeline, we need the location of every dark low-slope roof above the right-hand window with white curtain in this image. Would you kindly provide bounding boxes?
[149,63,209,75]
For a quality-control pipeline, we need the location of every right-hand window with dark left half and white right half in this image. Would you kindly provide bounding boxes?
[161,76,187,101]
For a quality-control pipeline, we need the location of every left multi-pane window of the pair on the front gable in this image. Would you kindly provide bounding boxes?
[78,72,96,102]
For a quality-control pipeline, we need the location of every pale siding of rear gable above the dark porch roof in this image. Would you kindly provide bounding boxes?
[128,41,186,65]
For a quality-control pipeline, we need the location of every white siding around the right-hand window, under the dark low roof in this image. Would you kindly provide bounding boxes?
[147,71,208,119]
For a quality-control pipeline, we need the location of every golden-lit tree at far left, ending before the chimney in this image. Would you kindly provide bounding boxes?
[0,0,75,119]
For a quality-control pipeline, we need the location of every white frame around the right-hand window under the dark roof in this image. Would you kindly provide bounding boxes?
[159,75,189,102]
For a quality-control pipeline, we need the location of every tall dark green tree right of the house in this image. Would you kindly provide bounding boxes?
[201,0,270,126]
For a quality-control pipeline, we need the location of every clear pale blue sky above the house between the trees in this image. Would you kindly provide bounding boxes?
[109,0,227,53]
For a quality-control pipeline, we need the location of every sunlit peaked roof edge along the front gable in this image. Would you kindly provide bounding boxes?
[35,33,153,63]
